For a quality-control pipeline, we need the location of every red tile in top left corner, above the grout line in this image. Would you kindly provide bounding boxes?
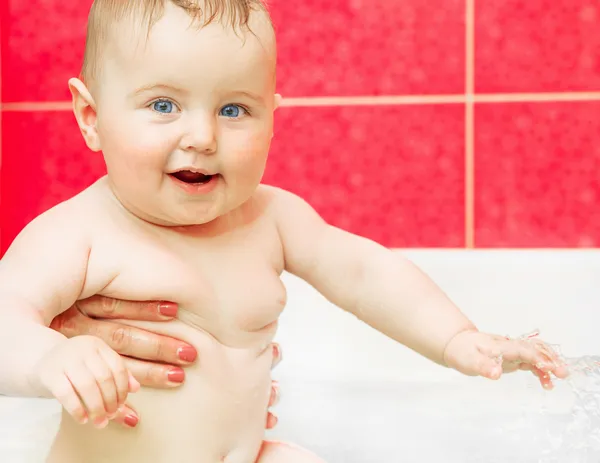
[1,0,92,102]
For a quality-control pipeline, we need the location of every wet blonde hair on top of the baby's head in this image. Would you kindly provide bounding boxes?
[81,0,270,83]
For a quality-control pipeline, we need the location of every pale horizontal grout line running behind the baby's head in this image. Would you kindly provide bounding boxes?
[0,91,600,112]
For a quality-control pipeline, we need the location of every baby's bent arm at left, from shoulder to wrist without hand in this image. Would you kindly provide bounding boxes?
[0,203,91,396]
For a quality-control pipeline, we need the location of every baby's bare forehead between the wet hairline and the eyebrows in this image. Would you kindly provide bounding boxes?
[101,10,276,93]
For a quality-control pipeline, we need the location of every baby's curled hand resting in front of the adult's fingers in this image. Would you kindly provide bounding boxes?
[33,336,140,428]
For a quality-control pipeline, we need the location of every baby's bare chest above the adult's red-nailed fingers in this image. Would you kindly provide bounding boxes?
[88,227,286,333]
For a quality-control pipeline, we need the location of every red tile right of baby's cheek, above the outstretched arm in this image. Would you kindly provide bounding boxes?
[265,105,464,247]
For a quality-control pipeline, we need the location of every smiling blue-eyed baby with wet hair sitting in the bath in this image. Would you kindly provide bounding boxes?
[0,0,566,463]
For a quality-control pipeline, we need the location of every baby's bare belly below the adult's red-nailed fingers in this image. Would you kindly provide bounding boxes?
[49,322,272,463]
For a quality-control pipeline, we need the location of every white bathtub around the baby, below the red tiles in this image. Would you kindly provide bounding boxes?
[0,251,600,463]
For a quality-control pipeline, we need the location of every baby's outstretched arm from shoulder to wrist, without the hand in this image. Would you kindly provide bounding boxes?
[269,188,475,365]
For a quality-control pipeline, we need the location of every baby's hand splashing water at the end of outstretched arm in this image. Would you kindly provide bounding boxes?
[444,331,568,389]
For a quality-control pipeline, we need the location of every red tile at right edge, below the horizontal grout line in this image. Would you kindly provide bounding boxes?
[475,102,600,247]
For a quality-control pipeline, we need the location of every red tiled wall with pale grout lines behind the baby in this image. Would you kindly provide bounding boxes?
[0,0,600,252]
